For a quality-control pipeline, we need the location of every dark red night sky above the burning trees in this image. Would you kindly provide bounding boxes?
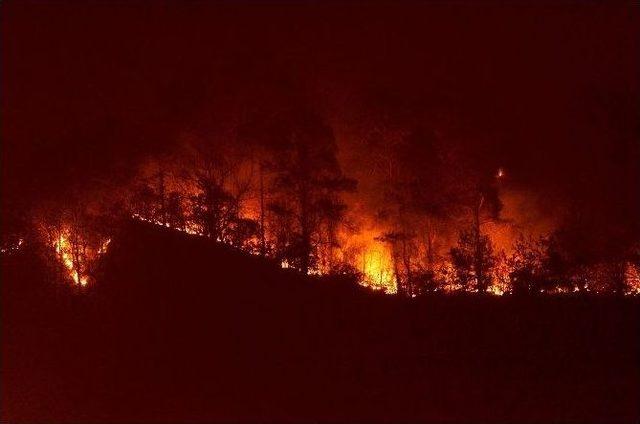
[0,1,640,227]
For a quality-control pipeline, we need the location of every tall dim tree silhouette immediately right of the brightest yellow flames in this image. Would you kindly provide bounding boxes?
[365,106,450,297]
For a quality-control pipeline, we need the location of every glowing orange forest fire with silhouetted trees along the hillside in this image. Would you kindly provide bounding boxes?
[16,150,640,298]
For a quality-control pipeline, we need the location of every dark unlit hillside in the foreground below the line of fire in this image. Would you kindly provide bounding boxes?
[0,224,640,423]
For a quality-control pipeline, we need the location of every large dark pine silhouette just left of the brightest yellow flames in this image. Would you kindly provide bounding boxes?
[258,109,355,274]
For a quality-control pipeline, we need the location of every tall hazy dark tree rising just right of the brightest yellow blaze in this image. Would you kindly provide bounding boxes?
[363,92,468,294]
